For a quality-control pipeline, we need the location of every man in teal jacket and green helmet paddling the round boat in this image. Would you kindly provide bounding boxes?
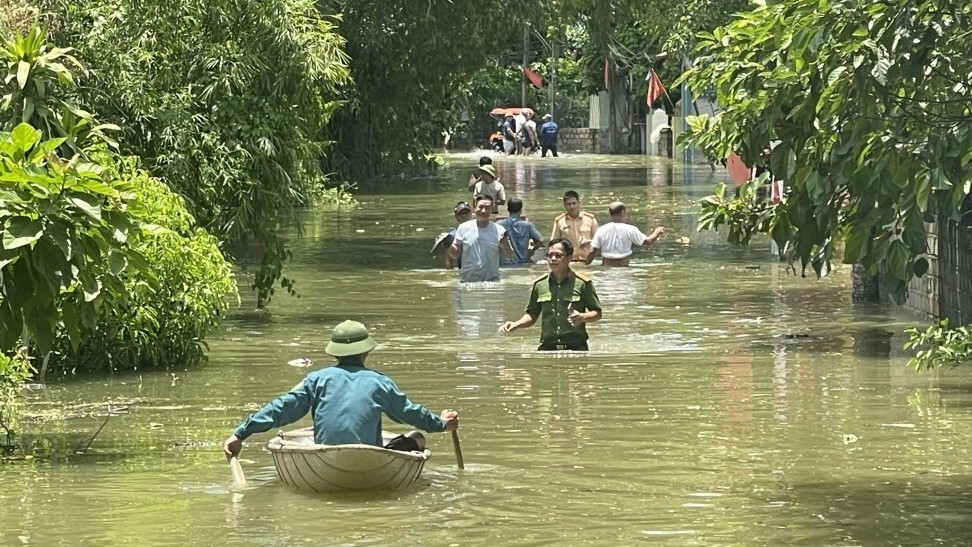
[223,321,459,458]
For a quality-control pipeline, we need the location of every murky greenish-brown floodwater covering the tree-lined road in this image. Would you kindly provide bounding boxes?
[0,156,972,546]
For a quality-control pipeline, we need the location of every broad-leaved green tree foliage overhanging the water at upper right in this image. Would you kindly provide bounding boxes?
[687,0,972,302]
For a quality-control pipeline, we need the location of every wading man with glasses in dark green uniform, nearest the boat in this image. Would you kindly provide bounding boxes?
[500,238,601,351]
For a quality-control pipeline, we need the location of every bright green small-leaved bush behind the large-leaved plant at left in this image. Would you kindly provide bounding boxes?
[51,153,236,372]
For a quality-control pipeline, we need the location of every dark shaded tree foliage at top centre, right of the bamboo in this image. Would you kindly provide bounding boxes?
[318,0,540,180]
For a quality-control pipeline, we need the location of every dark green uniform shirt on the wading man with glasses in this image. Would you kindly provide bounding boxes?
[526,271,601,345]
